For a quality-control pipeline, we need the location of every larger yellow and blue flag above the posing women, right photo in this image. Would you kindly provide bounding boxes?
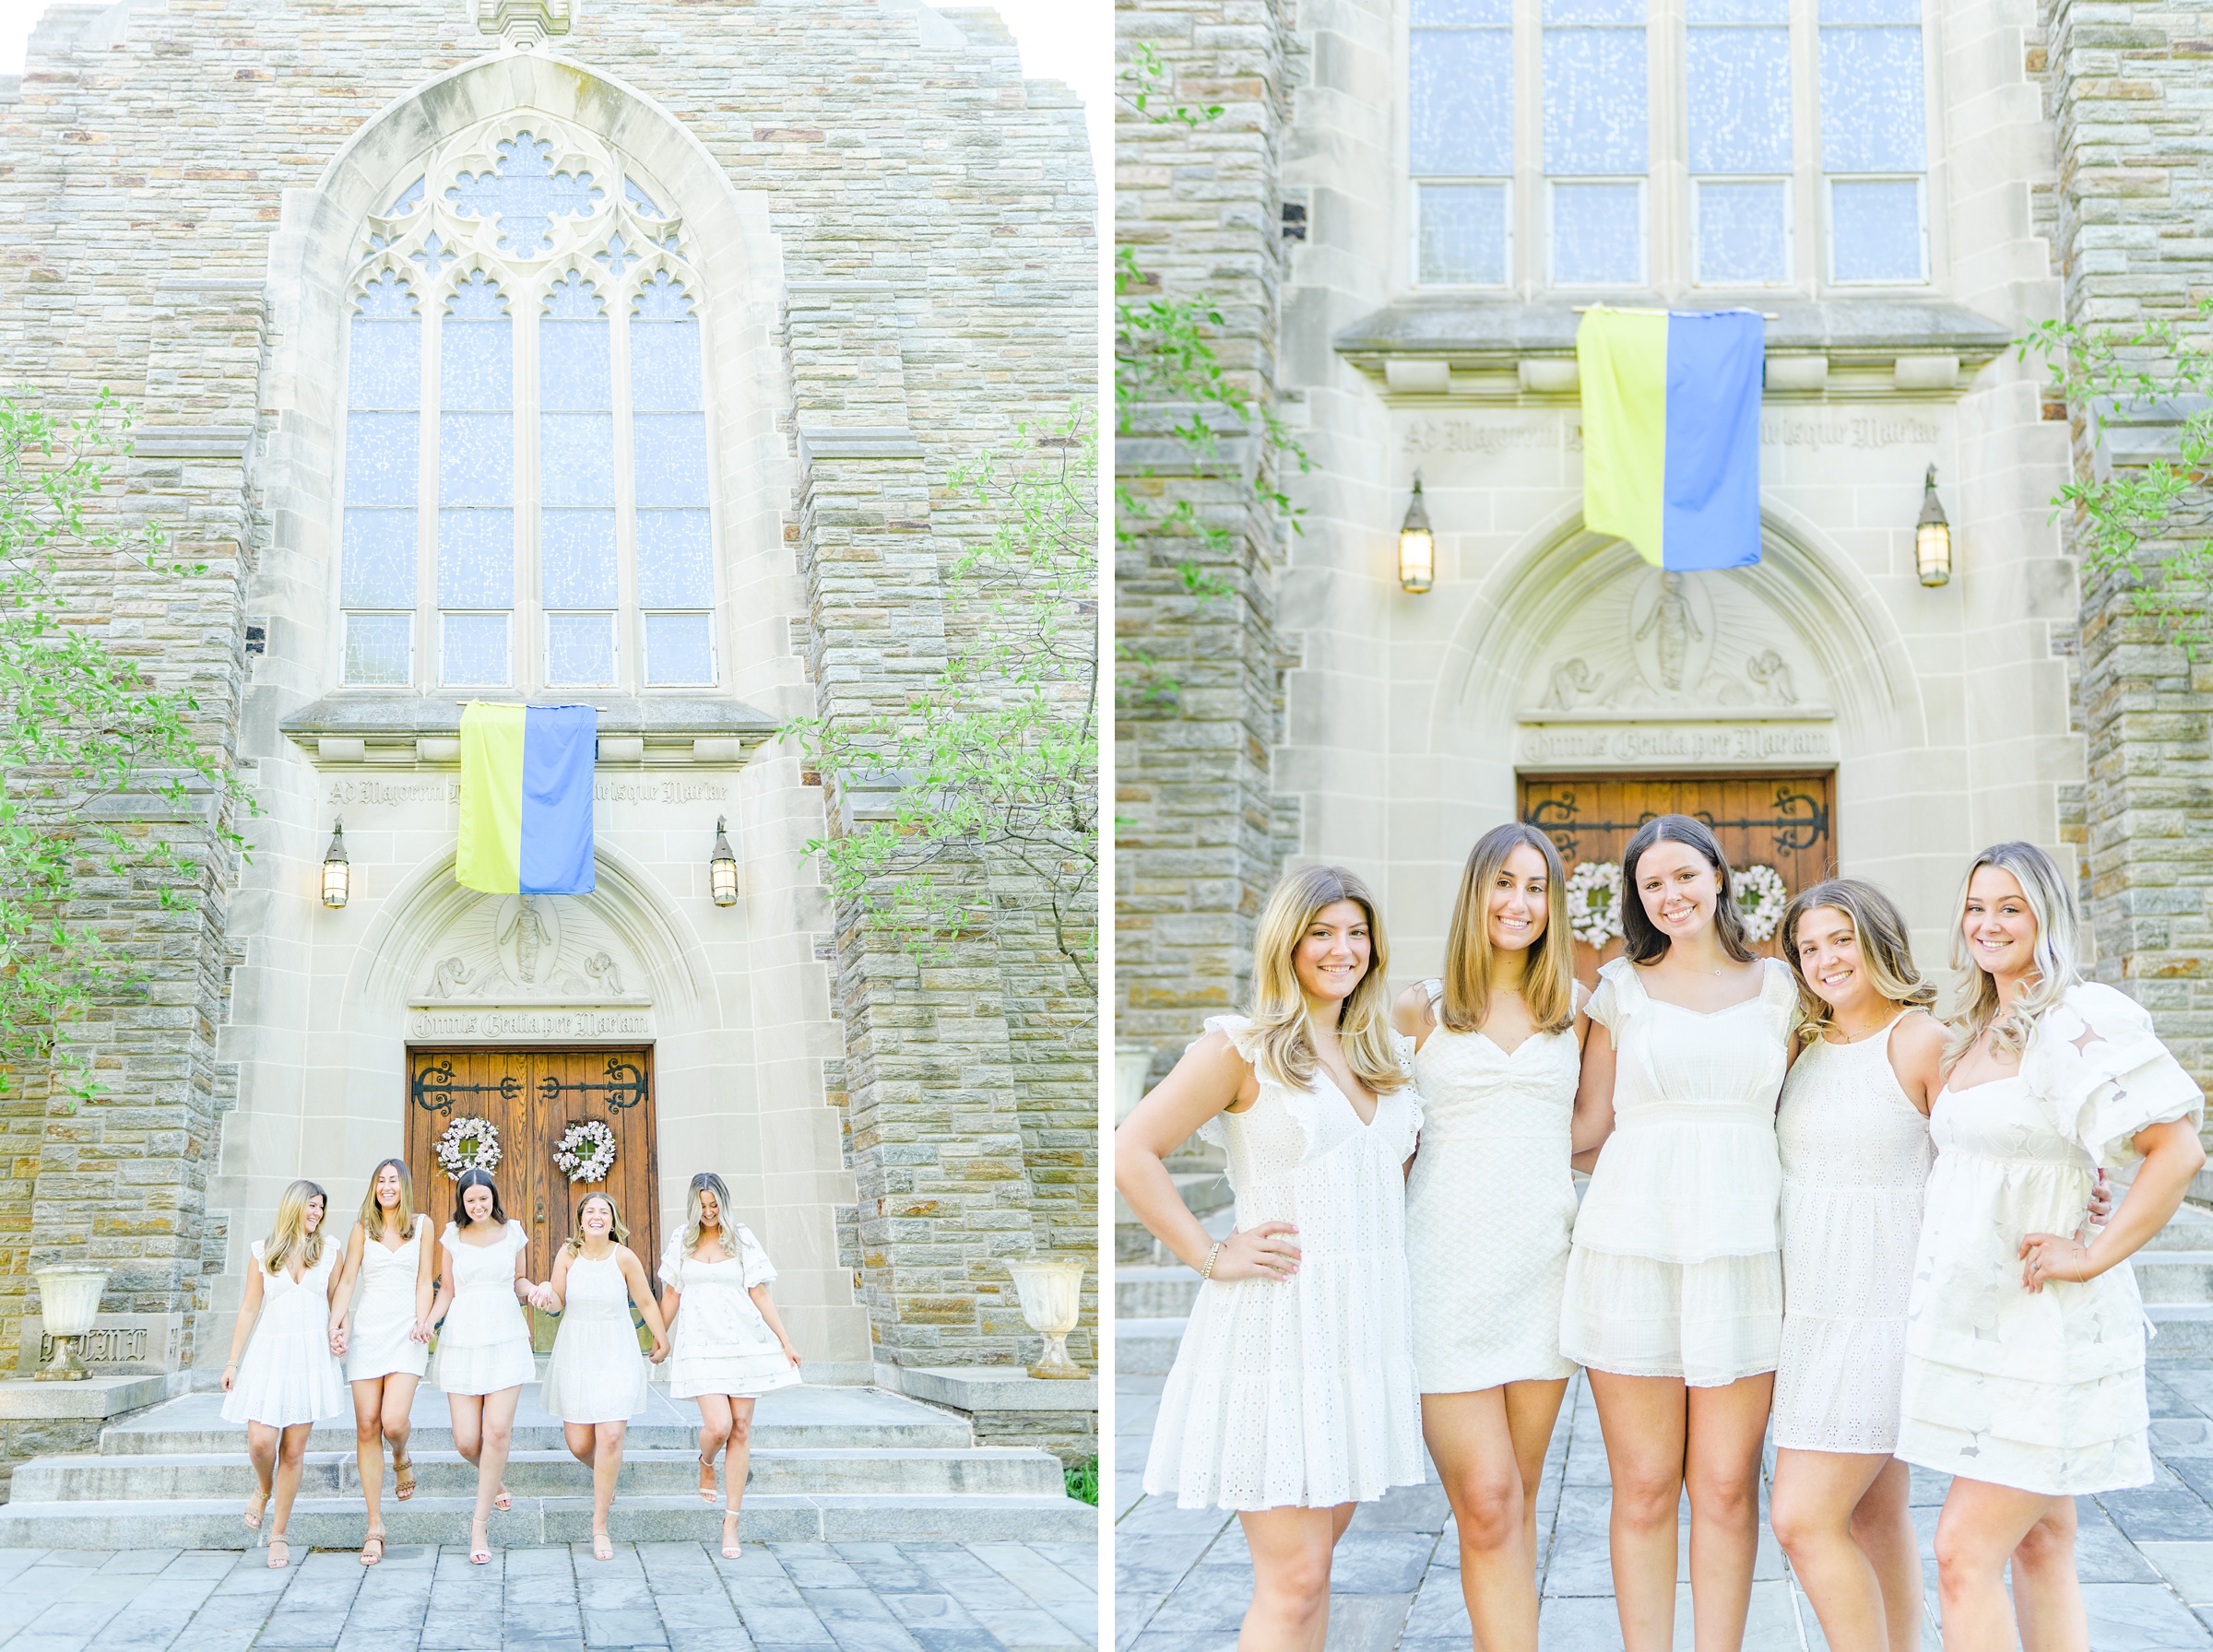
[1576,307,1766,569]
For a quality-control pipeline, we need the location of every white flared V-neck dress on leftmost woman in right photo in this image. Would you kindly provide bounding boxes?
[1144,1015,1423,1508]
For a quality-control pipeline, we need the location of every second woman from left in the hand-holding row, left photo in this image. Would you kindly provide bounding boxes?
[330,1159,438,1565]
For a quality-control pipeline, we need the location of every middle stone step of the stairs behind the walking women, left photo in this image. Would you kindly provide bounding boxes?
[11,1440,1062,1506]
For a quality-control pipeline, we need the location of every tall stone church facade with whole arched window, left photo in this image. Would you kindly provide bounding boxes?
[0,0,1097,1435]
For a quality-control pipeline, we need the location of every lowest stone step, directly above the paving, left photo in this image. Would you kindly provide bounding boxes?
[0,1495,1097,1564]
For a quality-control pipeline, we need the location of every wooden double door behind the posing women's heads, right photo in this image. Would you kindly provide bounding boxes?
[1521,774,1837,985]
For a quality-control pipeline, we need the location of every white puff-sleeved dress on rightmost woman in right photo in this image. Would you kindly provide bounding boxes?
[1897,985,2204,1497]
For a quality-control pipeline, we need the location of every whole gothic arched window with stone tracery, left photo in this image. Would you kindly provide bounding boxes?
[338,112,717,690]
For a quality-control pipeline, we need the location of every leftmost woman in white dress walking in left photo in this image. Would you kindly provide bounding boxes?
[223,1181,345,1570]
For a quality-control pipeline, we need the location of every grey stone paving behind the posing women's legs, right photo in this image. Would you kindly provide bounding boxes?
[1115,1363,2213,1652]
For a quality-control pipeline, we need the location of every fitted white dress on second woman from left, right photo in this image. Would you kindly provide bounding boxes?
[1405,982,1582,1393]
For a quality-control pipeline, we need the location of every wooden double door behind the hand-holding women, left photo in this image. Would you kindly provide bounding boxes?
[408,1046,662,1351]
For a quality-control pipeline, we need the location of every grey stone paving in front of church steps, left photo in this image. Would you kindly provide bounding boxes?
[0,1543,1097,1652]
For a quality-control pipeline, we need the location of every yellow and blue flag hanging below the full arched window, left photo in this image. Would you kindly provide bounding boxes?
[454,701,599,896]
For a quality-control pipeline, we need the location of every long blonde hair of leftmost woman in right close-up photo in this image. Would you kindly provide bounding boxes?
[1252,867,1407,1094]
